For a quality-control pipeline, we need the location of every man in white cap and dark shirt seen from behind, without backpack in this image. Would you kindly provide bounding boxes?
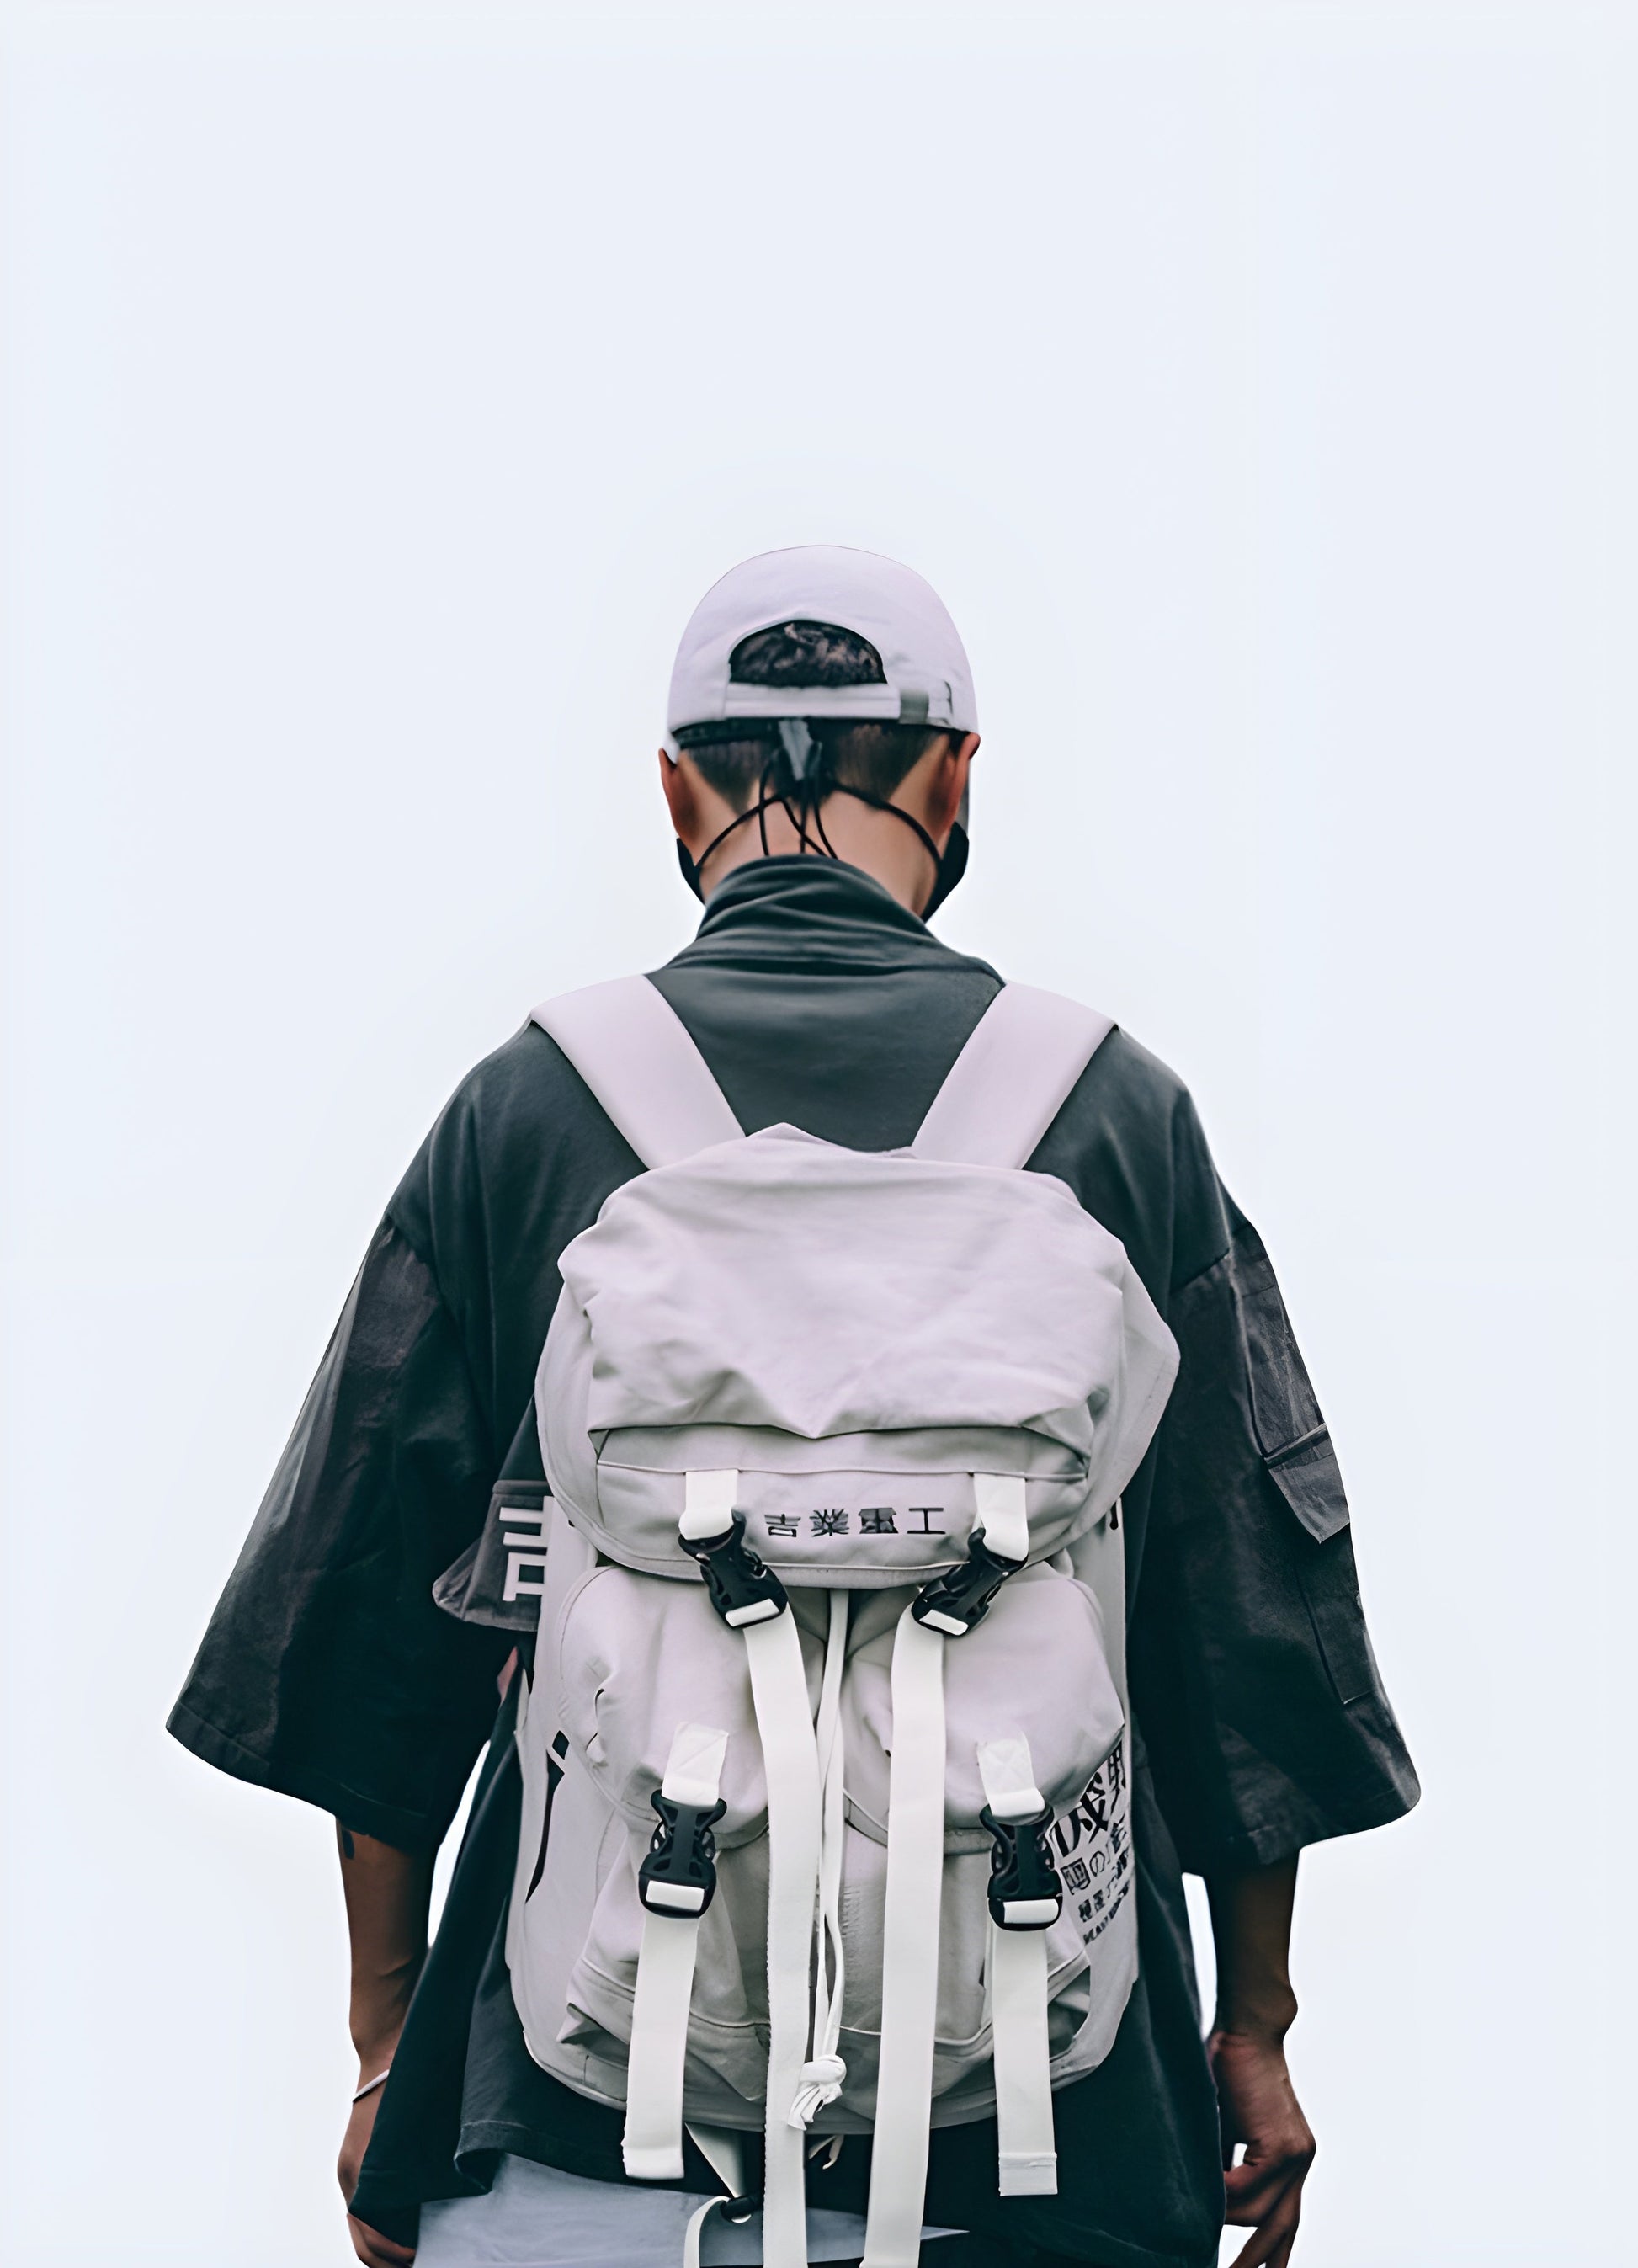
[170,546,1416,2268]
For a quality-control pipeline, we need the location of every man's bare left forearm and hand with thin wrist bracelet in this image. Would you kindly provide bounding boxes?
[336,1821,433,2268]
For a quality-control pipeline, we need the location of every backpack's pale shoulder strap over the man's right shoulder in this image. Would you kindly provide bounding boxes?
[910,984,1114,1166]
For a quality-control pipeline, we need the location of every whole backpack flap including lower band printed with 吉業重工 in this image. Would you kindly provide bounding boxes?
[538,1127,1175,1588]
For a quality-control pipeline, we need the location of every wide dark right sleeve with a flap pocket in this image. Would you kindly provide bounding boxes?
[1132,1197,1418,1873]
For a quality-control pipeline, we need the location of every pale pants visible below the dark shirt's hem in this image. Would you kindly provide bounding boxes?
[415,2157,950,2268]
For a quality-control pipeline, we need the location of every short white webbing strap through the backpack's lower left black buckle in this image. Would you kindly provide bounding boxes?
[620,1723,728,2182]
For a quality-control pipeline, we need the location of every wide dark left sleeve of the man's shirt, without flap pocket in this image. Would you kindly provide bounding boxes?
[170,1220,510,1850]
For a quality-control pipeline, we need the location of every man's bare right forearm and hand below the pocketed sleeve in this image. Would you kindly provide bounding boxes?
[1207,1857,1314,2268]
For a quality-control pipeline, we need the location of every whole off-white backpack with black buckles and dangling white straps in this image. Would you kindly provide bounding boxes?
[506,977,1178,2268]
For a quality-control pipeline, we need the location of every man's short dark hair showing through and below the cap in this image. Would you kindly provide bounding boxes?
[676,621,944,812]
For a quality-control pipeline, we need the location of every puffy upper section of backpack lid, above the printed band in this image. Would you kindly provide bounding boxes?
[558,1127,1128,1458]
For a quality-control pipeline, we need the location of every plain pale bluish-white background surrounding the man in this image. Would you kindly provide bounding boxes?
[3,0,1638,2268]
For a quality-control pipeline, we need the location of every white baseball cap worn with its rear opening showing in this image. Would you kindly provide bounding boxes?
[665,545,978,732]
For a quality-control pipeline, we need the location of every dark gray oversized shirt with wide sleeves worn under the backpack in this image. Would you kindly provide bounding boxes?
[170,857,1416,2268]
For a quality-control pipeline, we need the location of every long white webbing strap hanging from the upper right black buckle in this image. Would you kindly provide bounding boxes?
[864,1608,946,2268]
